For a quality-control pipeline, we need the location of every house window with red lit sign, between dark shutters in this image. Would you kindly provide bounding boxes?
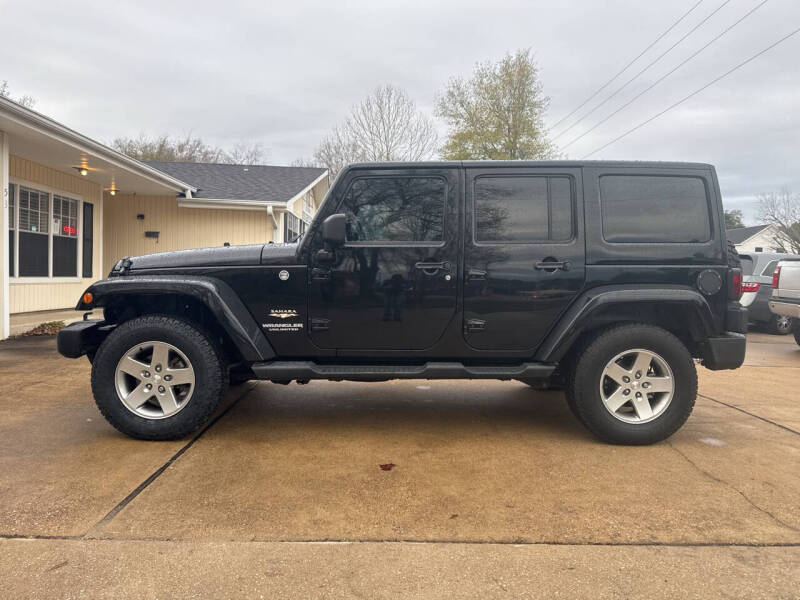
[9,185,80,277]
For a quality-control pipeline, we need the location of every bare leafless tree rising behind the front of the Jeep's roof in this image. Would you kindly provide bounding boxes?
[314,85,438,176]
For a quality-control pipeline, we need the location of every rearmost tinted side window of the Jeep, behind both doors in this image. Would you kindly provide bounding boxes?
[600,175,711,244]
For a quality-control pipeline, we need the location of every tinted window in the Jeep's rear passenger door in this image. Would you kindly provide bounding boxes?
[474,176,572,243]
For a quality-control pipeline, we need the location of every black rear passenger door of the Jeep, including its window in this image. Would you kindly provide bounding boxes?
[464,168,585,351]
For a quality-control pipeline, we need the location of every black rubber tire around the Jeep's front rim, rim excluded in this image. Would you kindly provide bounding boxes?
[92,315,228,440]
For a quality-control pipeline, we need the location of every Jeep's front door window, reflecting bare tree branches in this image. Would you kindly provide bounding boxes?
[341,177,447,242]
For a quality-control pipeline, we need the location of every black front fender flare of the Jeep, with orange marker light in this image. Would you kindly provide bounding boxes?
[76,275,275,362]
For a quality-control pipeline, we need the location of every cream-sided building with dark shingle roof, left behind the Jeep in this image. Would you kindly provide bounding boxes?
[0,97,328,339]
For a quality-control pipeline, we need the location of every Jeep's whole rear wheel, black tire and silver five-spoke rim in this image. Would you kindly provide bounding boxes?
[568,324,697,445]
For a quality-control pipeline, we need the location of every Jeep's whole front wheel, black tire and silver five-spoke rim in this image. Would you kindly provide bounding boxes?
[92,315,227,440]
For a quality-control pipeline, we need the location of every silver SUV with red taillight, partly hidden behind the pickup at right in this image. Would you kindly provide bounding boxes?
[739,252,800,335]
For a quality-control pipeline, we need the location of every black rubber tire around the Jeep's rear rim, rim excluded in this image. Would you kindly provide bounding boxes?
[567,324,697,445]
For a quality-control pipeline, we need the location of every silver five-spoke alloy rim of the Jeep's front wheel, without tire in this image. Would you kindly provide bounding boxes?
[114,341,195,419]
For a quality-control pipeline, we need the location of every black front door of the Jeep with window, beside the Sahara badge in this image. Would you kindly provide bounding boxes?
[309,168,461,352]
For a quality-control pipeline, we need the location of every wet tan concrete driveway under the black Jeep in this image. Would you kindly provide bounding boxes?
[0,334,800,598]
